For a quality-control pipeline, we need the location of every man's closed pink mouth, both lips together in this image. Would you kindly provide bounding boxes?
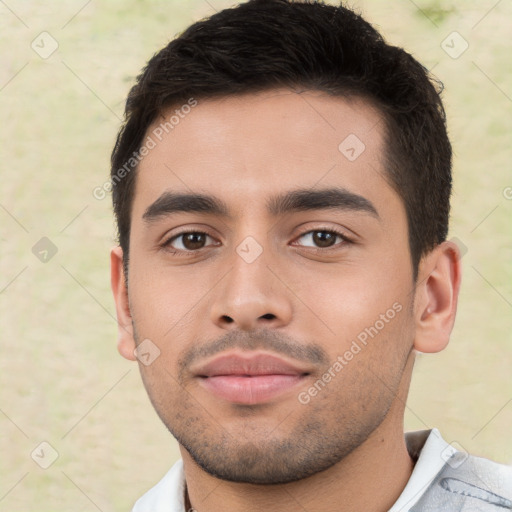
[194,352,310,405]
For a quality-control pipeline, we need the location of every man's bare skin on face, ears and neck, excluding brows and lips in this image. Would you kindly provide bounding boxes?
[111,89,460,512]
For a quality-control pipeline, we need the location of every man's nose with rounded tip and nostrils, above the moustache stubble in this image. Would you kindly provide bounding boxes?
[211,245,293,330]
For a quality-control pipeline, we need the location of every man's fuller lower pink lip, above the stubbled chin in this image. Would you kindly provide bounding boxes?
[200,375,304,405]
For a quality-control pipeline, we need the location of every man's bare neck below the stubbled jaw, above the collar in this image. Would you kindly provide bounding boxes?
[181,404,414,512]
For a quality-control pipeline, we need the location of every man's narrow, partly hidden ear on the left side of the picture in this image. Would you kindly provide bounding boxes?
[110,247,136,361]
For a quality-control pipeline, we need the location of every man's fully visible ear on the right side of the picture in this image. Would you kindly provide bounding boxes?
[414,242,462,353]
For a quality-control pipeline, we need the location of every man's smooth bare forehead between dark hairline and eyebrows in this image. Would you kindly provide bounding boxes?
[133,89,398,217]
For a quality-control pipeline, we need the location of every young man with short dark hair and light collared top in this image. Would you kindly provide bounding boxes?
[111,0,512,512]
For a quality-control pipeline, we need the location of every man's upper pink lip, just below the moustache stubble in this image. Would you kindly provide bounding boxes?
[193,352,309,377]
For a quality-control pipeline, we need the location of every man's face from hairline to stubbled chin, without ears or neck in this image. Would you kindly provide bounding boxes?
[123,89,414,483]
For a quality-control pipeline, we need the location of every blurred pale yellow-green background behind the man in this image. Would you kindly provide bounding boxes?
[0,0,512,512]
